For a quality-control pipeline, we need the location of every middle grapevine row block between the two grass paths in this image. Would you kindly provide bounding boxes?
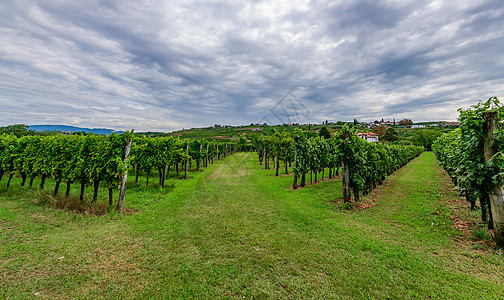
[252,128,424,200]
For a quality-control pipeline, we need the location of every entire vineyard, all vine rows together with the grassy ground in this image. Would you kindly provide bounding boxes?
[0,98,504,299]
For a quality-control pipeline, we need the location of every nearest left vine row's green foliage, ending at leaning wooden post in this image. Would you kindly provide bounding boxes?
[0,132,144,195]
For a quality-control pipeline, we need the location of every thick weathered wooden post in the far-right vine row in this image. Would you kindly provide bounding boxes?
[483,111,504,247]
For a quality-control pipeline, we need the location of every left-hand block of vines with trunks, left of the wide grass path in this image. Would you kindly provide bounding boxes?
[0,132,238,210]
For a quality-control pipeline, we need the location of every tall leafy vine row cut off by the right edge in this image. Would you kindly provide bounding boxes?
[433,97,504,247]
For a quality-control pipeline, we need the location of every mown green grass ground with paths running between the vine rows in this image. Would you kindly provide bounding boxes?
[0,153,504,299]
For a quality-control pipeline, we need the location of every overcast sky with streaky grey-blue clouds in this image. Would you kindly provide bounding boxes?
[0,0,504,131]
